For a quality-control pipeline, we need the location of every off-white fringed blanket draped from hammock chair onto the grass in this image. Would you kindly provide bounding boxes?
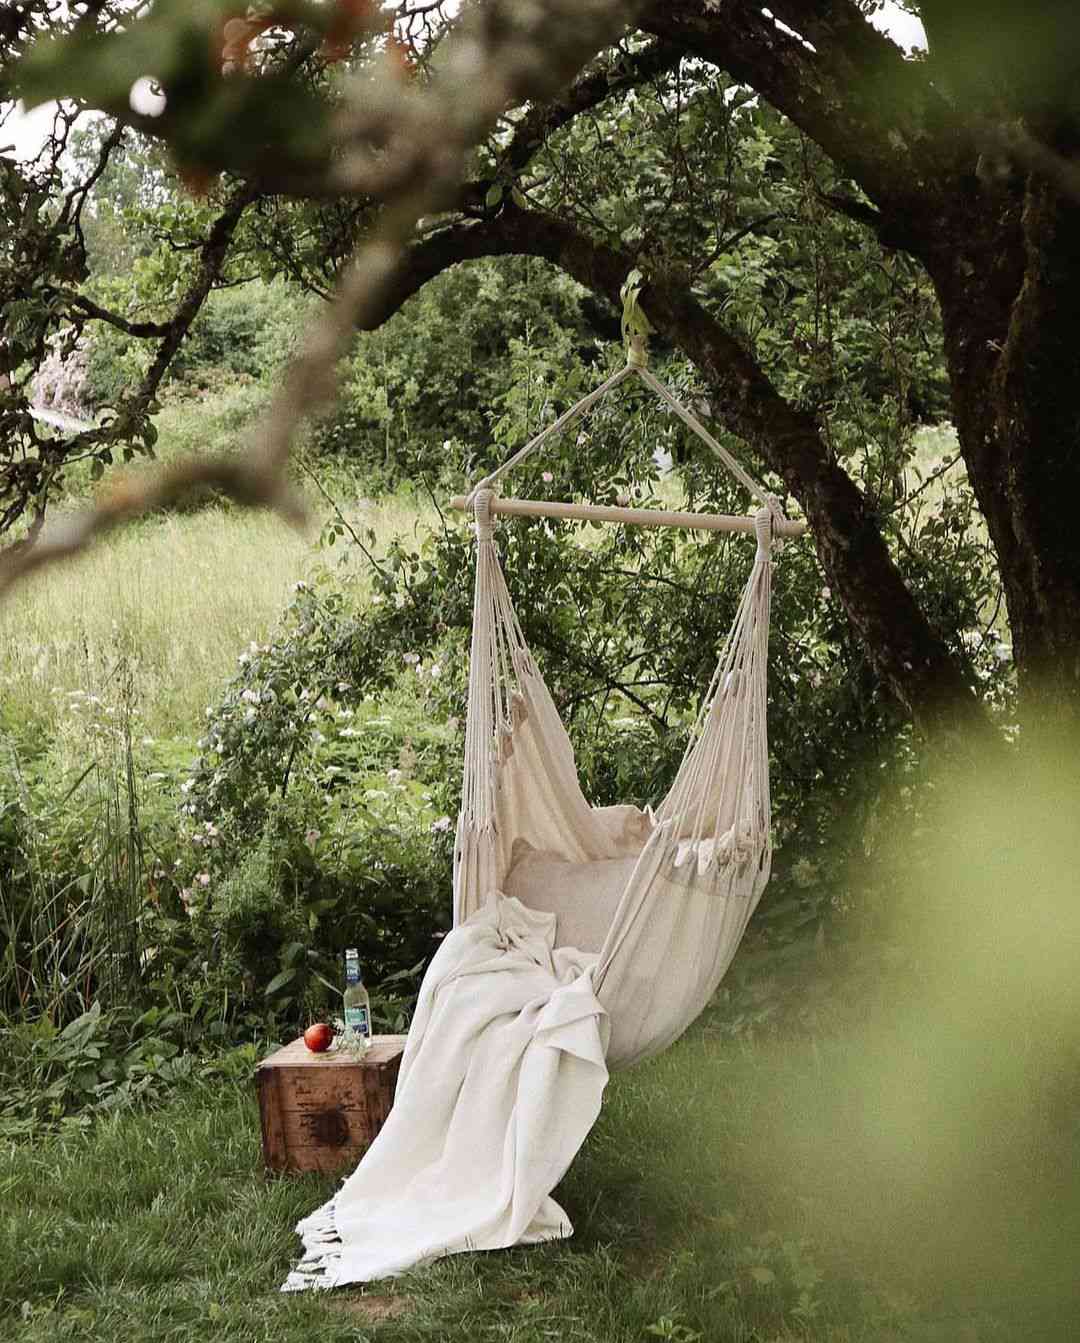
[281,896,609,1292]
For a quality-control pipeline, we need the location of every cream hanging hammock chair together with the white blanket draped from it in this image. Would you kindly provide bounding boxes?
[282,333,802,1291]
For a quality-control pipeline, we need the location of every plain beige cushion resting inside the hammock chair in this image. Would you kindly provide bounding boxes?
[504,839,638,952]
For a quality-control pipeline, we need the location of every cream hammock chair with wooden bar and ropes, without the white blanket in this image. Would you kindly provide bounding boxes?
[453,338,805,1066]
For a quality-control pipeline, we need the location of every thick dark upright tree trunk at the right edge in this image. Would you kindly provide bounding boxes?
[924,180,1080,717]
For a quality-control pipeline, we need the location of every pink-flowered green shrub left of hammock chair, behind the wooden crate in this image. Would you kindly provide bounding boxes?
[168,575,462,1023]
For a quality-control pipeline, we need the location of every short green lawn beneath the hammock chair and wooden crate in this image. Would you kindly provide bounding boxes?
[0,1027,1047,1343]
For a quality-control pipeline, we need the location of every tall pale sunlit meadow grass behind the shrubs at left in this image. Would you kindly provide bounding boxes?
[0,389,427,737]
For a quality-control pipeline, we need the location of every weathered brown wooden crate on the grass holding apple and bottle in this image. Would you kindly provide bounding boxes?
[255,1035,406,1172]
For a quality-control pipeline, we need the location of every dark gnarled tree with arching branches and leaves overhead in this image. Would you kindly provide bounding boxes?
[0,0,1080,732]
